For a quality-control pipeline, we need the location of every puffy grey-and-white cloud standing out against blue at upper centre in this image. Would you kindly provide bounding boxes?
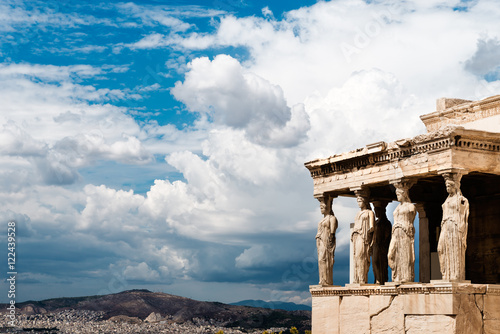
[172,55,309,146]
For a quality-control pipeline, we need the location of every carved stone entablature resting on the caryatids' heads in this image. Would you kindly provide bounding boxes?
[305,126,500,195]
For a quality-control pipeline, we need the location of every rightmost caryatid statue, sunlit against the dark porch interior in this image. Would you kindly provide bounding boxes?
[438,173,469,280]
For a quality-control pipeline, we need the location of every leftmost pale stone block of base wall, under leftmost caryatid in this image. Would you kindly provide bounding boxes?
[311,296,340,334]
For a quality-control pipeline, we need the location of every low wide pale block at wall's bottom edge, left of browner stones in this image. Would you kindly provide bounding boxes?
[403,315,458,334]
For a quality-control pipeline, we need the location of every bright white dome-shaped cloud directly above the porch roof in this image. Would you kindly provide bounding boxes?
[305,69,425,159]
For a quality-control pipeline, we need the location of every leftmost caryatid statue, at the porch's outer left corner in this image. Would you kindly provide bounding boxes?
[316,196,338,285]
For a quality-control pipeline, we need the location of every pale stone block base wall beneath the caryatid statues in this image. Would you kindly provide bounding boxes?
[311,282,500,334]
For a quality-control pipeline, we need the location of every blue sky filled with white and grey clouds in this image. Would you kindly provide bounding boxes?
[0,0,500,304]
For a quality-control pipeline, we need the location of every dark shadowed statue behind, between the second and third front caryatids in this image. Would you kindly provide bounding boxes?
[372,201,392,284]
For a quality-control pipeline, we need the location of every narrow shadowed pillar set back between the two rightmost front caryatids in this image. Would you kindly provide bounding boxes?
[416,203,431,283]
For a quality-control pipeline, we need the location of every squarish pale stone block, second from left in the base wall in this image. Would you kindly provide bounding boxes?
[338,296,370,334]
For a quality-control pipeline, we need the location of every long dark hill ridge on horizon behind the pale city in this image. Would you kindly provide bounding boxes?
[0,290,311,331]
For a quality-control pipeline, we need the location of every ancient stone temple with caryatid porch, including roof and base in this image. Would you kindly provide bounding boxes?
[305,95,500,334]
